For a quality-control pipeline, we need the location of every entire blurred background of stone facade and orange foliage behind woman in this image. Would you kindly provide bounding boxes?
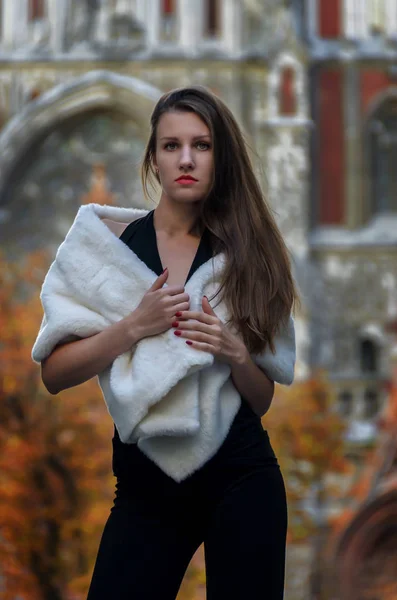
[0,0,397,600]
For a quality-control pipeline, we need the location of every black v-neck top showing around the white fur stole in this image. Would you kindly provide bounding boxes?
[113,210,274,476]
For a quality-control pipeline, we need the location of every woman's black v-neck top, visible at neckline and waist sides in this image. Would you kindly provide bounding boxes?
[113,210,274,477]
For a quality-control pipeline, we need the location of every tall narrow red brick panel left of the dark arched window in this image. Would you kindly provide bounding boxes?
[317,69,345,225]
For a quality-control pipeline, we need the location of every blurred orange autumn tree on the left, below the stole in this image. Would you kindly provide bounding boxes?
[0,254,113,600]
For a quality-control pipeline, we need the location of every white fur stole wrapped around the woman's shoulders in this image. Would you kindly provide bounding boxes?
[32,204,295,481]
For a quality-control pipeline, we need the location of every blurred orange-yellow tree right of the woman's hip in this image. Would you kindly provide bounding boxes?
[263,371,353,598]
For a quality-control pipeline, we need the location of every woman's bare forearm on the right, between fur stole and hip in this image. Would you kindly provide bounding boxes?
[230,349,274,417]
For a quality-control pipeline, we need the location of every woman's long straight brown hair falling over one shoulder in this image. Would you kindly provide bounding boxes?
[142,86,298,353]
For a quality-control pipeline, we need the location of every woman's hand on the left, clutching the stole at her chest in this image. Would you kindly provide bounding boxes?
[130,269,190,337]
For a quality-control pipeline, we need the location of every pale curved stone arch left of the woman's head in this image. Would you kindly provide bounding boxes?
[0,70,161,203]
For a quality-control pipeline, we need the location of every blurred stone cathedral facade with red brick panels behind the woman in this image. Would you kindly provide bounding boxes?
[0,0,397,445]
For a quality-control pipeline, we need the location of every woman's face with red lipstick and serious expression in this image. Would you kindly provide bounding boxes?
[154,111,214,202]
